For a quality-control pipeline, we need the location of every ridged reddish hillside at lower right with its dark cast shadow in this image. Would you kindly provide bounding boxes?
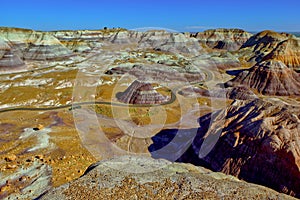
[149,99,300,197]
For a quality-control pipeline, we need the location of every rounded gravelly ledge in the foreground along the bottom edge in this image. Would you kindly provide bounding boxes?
[40,156,294,200]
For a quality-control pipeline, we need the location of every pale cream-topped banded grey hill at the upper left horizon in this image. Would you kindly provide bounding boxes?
[0,28,72,60]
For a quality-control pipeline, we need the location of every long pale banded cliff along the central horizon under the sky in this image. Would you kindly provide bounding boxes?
[51,28,202,54]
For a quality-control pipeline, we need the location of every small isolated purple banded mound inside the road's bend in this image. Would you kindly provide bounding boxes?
[117,80,170,105]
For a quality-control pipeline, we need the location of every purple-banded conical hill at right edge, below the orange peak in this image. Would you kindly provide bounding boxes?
[225,60,300,96]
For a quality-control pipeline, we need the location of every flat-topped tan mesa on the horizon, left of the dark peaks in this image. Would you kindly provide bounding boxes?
[192,29,252,51]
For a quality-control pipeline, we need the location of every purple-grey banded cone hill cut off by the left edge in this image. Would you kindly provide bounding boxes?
[0,38,26,72]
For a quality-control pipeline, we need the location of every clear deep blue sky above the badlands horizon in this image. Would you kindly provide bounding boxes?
[0,0,300,31]
